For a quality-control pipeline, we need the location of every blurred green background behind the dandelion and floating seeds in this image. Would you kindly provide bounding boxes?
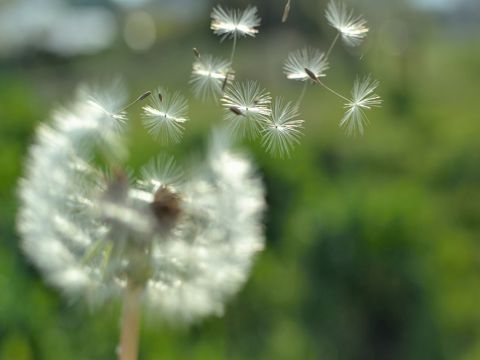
[0,0,480,360]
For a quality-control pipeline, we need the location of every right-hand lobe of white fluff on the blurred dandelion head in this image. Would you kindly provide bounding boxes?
[146,134,264,322]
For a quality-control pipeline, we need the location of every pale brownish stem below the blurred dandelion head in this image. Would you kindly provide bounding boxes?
[118,282,142,360]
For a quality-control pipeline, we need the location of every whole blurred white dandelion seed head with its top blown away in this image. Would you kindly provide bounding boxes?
[18,87,265,323]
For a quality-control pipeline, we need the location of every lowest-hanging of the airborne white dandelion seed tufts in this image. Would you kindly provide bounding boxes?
[262,98,304,157]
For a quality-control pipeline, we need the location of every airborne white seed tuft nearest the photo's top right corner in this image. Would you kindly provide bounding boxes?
[325,0,368,46]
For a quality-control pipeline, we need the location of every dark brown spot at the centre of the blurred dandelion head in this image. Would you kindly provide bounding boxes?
[150,186,182,232]
